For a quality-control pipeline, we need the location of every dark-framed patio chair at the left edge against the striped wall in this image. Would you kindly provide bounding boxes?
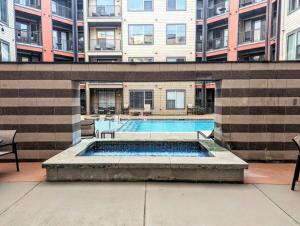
[0,130,19,171]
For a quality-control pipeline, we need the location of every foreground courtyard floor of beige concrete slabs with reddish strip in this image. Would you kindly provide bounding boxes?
[0,163,300,226]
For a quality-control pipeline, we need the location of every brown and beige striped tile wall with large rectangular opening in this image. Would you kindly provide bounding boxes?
[0,62,300,160]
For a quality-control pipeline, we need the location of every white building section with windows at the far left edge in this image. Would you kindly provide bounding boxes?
[0,0,16,62]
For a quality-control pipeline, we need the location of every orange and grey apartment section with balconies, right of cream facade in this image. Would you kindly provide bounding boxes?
[196,0,280,61]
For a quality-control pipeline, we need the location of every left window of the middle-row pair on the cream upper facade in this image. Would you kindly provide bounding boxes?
[128,25,153,45]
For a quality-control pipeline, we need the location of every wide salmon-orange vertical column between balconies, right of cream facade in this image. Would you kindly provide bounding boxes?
[227,0,239,61]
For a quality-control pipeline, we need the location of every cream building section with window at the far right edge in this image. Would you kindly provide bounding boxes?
[280,0,300,60]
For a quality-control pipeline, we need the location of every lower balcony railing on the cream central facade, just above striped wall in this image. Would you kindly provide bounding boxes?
[90,38,121,51]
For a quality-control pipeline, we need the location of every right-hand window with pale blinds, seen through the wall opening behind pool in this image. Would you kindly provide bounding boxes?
[167,90,185,110]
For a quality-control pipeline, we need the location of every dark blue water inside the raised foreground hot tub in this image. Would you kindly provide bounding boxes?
[80,141,212,157]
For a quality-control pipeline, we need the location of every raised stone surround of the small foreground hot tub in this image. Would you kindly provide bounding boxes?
[43,138,248,183]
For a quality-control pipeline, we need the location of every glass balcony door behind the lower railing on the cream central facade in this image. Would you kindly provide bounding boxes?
[97,29,116,50]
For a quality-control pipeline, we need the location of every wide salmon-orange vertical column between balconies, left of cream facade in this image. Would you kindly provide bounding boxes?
[41,0,54,62]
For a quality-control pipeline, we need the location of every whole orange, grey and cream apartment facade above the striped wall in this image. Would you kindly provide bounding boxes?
[0,0,288,62]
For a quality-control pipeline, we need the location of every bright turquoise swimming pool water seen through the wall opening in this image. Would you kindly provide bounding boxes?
[96,120,214,132]
